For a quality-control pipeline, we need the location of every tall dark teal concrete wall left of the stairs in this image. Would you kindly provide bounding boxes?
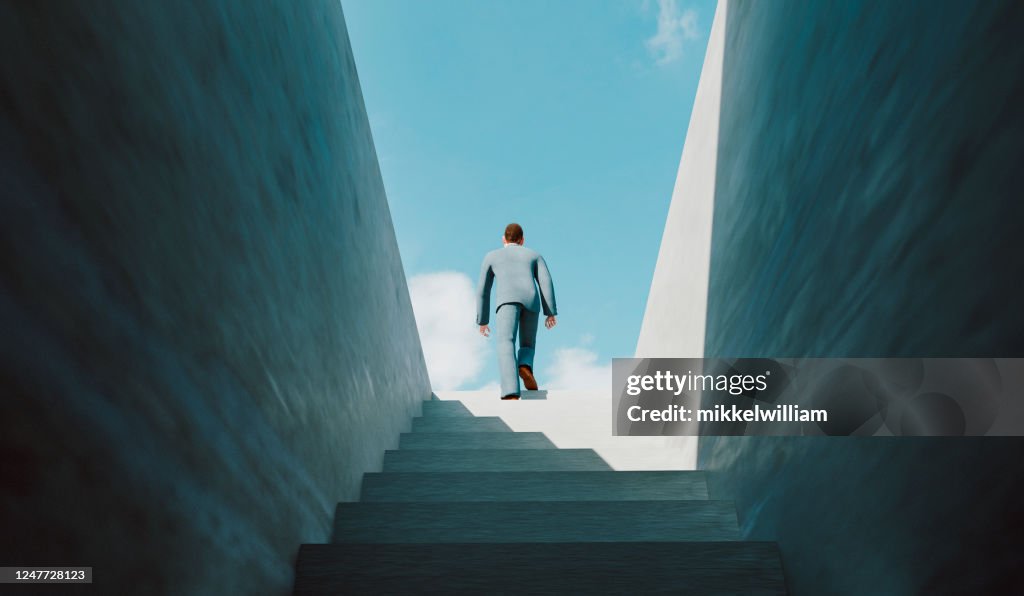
[0,0,430,594]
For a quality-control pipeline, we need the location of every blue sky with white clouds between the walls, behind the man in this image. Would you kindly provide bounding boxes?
[342,0,715,391]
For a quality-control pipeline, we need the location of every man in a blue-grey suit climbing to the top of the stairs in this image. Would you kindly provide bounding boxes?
[476,223,558,399]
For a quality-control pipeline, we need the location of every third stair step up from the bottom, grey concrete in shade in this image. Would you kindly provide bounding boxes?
[359,475,708,502]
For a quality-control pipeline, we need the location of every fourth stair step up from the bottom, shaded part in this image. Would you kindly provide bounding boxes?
[383,449,611,472]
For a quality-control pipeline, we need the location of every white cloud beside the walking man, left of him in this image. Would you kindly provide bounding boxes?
[409,271,490,390]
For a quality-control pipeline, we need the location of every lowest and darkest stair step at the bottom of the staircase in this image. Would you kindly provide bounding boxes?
[294,542,786,596]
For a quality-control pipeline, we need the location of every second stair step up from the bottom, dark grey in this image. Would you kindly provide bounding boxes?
[333,501,739,544]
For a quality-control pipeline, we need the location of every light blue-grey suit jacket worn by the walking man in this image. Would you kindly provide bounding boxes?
[476,244,558,325]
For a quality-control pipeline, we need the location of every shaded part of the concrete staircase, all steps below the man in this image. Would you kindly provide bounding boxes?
[295,400,786,594]
